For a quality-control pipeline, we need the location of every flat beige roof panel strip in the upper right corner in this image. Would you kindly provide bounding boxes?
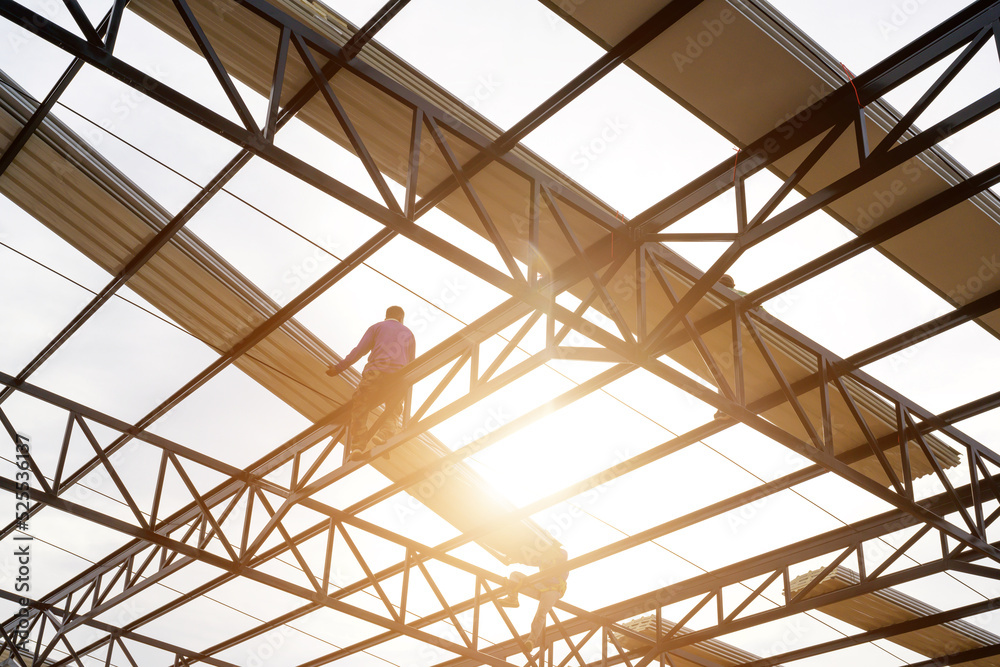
[549,0,1000,344]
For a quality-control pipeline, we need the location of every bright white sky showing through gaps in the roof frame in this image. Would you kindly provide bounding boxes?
[0,0,1000,666]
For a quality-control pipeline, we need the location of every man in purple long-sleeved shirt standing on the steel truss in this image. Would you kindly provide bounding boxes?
[326,306,416,461]
